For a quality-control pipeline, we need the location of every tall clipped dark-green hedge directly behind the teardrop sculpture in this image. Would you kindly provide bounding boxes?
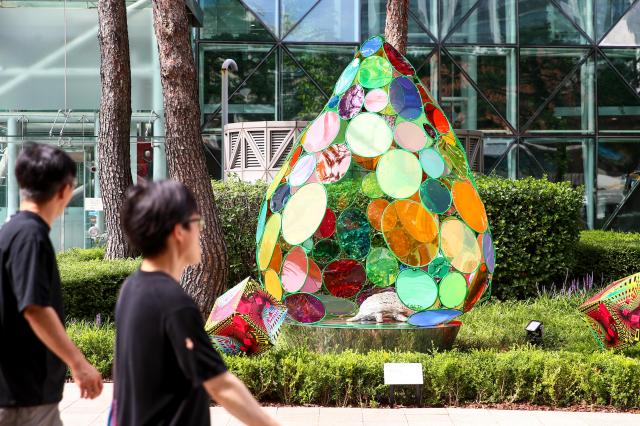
[213,177,582,298]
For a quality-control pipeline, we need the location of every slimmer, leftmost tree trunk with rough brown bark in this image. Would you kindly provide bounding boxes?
[98,0,135,259]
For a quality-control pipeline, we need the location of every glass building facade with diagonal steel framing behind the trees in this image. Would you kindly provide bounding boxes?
[0,0,640,249]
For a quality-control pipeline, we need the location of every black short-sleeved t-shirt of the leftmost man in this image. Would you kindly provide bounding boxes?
[0,211,66,407]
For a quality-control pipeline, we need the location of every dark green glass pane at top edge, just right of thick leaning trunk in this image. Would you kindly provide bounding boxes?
[200,0,272,41]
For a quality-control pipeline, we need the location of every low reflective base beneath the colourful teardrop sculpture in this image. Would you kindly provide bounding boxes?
[279,318,462,352]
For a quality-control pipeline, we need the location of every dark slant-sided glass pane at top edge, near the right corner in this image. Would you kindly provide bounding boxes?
[518,0,588,45]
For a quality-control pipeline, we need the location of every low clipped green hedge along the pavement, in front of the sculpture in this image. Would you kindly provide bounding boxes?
[67,323,640,409]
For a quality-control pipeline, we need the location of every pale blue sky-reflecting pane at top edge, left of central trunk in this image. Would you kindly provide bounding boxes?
[285,0,358,42]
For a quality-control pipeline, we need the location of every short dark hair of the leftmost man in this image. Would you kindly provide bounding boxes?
[15,142,76,203]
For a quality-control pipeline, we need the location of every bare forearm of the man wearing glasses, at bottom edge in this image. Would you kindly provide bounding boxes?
[204,372,279,426]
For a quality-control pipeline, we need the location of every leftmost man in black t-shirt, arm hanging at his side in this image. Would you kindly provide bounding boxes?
[0,144,102,426]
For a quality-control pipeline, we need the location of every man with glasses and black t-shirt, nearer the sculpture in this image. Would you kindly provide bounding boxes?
[112,181,277,426]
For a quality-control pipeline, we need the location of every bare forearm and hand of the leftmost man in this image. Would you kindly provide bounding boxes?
[23,305,102,399]
